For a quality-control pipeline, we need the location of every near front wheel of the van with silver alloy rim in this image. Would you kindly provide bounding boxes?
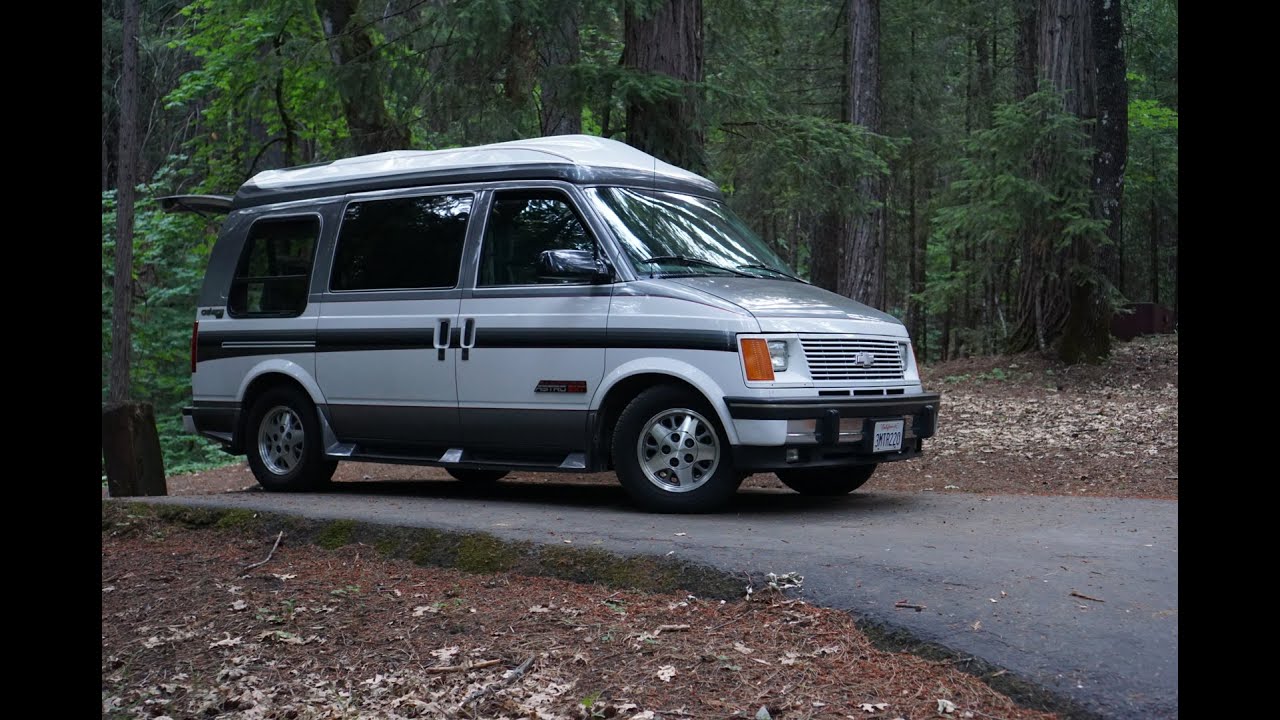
[613,386,742,512]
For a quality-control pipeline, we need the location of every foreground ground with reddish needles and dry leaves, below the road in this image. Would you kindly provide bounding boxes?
[102,519,1053,720]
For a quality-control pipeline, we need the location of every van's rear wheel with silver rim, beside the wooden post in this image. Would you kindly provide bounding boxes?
[247,386,338,492]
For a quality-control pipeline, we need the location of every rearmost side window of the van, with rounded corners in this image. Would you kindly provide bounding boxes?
[228,217,320,318]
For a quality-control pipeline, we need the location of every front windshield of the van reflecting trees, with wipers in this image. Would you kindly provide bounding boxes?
[588,187,799,279]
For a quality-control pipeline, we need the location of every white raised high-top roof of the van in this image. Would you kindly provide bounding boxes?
[234,135,719,208]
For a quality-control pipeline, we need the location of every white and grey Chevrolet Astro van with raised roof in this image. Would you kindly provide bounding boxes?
[172,136,940,512]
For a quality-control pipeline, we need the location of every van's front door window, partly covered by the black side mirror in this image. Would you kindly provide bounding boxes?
[477,190,594,287]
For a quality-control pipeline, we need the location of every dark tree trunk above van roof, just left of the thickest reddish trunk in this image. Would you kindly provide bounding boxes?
[539,0,582,136]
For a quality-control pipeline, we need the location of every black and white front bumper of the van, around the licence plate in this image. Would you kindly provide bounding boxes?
[724,393,941,473]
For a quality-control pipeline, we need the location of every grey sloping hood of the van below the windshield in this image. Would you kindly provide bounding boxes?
[668,277,906,337]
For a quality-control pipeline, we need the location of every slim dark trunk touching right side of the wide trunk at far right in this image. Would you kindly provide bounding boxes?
[1091,0,1129,284]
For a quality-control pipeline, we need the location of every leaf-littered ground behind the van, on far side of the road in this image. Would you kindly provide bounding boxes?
[169,336,1178,500]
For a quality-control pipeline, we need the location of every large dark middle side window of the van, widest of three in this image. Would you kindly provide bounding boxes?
[329,195,471,291]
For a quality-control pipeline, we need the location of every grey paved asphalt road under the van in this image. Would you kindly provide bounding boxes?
[132,482,1178,719]
